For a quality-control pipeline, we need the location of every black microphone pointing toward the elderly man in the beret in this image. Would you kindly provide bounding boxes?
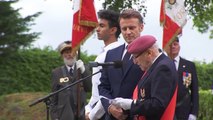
[89,61,123,68]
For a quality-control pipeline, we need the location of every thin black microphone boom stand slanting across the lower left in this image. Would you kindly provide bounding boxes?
[29,70,102,120]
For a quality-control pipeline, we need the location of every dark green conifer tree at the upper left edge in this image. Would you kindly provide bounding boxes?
[0,0,41,59]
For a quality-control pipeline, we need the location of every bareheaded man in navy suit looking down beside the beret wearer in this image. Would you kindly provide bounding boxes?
[98,9,143,120]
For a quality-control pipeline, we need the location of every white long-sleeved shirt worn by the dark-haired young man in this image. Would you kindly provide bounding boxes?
[85,42,121,120]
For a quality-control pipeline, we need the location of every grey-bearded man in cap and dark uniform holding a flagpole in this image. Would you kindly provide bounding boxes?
[51,41,91,120]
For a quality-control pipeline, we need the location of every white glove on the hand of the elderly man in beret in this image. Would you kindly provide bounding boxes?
[112,98,133,110]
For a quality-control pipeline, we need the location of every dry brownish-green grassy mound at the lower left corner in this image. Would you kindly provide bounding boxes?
[0,93,46,120]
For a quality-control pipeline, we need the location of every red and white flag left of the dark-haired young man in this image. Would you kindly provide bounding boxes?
[72,0,98,53]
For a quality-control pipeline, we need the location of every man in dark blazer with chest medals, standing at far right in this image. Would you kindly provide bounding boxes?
[166,38,199,120]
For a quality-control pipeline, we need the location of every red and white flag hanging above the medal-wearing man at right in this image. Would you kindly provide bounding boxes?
[160,0,187,49]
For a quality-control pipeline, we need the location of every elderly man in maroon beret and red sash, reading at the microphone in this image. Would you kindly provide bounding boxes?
[112,35,178,120]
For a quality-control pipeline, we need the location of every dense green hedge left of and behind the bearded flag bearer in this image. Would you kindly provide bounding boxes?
[0,47,95,95]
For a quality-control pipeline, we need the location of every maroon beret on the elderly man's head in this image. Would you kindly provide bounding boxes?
[127,35,157,54]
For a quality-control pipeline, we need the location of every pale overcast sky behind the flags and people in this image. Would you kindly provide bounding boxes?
[13,0,213,62]
